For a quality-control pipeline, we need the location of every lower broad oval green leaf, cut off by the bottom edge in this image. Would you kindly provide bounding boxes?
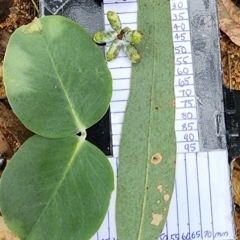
[0,135,114,240]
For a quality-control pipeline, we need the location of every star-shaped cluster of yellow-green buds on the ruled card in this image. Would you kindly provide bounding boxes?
[93,11,144,63]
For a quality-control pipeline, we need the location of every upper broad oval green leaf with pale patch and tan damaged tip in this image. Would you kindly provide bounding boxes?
[3,16,112,137]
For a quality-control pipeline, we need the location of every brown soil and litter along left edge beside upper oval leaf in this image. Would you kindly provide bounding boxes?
[0,0,37,178]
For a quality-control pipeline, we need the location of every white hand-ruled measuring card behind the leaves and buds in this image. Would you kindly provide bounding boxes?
[92,0,235,240]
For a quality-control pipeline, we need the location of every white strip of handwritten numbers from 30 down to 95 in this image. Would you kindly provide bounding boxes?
[171,0,199,153]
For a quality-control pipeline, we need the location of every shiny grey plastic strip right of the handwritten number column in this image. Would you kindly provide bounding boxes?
[188,0,227,151]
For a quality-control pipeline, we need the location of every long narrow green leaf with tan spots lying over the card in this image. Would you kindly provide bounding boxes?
[116,0,176,240]
